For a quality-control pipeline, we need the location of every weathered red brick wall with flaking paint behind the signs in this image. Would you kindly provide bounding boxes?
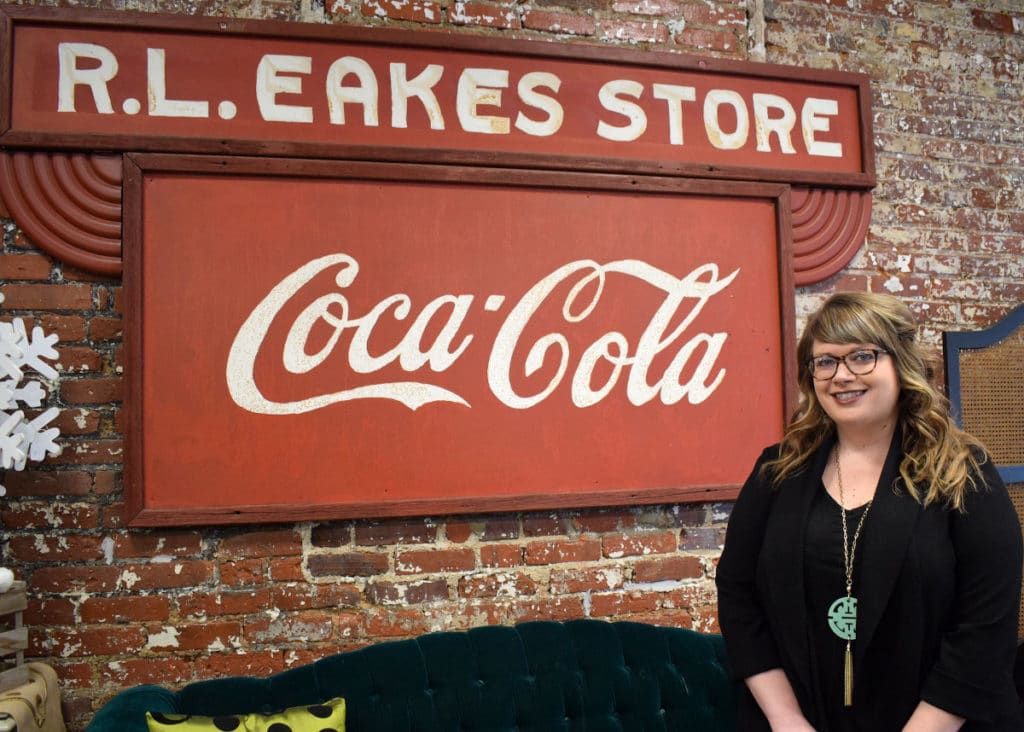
[0,0,1024,730]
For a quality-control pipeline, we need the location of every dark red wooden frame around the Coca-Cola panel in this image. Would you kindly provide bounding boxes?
[124,154,796,526]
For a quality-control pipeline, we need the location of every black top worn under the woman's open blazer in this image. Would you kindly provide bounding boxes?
[804,485,871,732]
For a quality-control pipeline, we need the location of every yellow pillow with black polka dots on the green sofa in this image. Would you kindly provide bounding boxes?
[145,697,345,732]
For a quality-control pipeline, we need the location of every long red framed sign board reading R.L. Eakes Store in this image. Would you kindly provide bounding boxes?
[0,8,874,187]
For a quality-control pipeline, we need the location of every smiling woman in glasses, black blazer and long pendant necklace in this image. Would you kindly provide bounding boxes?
[717,294,1024,732]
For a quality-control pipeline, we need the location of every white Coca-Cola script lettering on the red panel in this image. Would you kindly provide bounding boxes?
[226,253,739,415]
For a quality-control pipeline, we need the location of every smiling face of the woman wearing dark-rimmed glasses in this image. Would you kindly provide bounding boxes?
[811,340,899,436]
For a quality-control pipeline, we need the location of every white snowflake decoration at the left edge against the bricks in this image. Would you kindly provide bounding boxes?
[0,296,60,496]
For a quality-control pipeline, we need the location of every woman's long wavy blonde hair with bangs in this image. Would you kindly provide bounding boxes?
[765,293,985,510]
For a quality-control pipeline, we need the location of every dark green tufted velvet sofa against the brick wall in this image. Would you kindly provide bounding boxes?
[87,619,737,732]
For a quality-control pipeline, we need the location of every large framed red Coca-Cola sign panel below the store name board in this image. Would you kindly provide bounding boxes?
[125,156,793,525]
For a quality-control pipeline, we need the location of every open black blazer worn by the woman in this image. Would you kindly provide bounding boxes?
[716,431,1024,732]
